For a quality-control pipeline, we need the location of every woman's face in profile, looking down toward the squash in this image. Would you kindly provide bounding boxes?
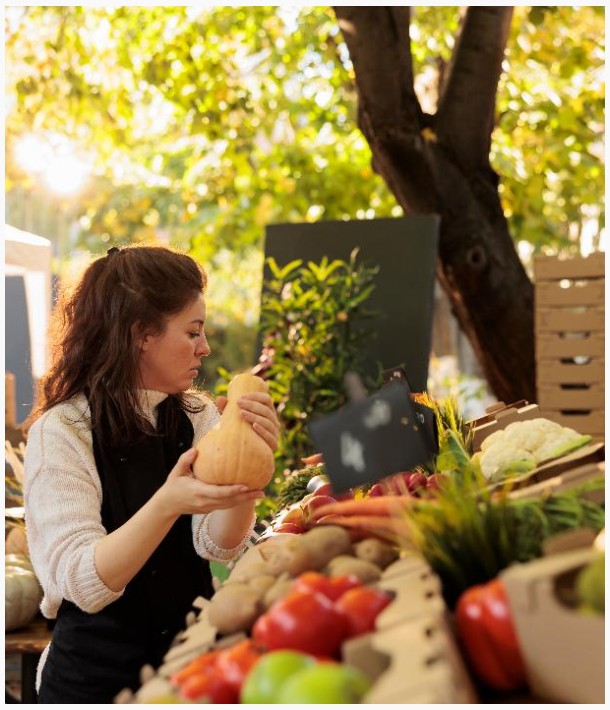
[139,294,210,394]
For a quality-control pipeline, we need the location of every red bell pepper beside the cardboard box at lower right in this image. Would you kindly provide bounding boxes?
[455,578,527,690]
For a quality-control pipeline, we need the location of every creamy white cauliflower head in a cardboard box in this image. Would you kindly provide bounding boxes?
[479,417,591,480]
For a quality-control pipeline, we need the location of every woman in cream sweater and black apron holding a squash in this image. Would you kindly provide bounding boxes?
[24,246,278,703]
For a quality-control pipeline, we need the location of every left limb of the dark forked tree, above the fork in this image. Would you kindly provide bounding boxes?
[333,6,421,134]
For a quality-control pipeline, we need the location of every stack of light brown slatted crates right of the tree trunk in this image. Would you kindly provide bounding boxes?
[534,252,605,440]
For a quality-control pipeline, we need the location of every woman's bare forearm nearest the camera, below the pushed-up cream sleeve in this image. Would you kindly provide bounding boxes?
[95,496,177,592]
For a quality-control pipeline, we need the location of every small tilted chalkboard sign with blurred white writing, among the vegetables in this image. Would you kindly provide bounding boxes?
[309,382,435,493]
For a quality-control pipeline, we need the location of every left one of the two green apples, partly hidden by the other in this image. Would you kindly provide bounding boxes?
[240,650,316,704]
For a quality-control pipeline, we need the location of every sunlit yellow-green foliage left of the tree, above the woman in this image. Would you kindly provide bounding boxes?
[7,7,394,263]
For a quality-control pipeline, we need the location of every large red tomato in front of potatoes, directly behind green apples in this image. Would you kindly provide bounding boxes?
[252,591,349,656]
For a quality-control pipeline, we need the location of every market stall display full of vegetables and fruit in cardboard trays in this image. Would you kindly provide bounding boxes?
[117,382,605,704]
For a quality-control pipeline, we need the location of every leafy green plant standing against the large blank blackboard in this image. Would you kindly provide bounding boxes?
[255,249,378,476]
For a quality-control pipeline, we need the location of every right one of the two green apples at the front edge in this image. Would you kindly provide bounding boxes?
[275,663,371,704]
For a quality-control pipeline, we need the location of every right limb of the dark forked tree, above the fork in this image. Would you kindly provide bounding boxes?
[435,6,513,170]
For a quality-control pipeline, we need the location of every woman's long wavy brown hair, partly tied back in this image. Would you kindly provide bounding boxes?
[24,245,207,446]
